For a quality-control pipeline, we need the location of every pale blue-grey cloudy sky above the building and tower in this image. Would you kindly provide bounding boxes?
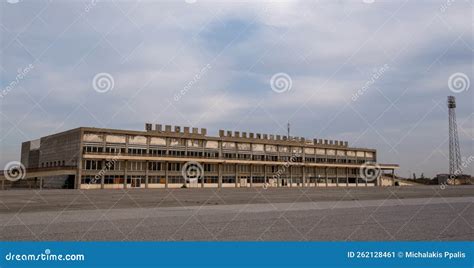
[0,0,474,176]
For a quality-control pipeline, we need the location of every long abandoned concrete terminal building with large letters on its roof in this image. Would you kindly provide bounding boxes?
[12,124,398,189]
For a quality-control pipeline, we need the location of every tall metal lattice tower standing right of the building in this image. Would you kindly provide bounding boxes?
[448,96,462,176]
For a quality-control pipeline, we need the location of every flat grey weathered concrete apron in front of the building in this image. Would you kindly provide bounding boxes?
[0,186,474,241]
